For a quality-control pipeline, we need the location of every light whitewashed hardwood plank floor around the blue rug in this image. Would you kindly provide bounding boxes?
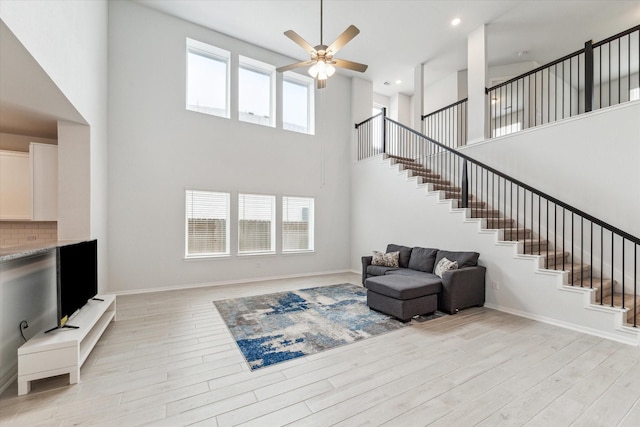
[0,274,640,427]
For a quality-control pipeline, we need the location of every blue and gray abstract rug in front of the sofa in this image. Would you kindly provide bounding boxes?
[214,283,409,370]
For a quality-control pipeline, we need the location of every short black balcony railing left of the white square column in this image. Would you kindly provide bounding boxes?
[421,98,467,148]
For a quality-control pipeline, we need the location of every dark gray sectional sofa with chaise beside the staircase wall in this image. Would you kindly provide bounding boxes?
[362,244,486,321]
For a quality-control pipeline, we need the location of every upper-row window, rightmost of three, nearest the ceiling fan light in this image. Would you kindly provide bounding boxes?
[282,72,314,135]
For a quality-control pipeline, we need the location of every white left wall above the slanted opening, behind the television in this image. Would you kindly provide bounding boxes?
[0,0,108,291]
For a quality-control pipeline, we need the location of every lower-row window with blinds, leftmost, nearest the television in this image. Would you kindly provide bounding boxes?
[185,190,230,258]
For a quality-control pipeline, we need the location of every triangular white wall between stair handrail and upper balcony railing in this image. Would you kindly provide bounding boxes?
[462,102,640,236]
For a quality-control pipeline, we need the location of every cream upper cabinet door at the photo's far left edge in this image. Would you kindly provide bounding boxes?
[0,150,31,221]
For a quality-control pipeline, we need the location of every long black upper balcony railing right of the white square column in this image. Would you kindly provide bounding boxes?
[486,25,640,138]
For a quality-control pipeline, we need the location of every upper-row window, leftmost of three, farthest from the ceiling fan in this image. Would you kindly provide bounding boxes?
[187,39,230,118]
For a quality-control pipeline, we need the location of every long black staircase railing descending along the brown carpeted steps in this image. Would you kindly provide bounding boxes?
[356,116,640,327]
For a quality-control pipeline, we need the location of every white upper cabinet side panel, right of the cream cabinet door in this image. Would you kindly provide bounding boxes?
[29,142,58,221]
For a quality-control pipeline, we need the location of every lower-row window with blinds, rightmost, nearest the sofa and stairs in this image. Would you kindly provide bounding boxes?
[282,197,313,252]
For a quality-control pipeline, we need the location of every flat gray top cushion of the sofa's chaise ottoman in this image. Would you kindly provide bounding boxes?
[365,274,442,301]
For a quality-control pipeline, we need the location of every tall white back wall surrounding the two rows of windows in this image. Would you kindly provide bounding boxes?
[109,2,352,292]
